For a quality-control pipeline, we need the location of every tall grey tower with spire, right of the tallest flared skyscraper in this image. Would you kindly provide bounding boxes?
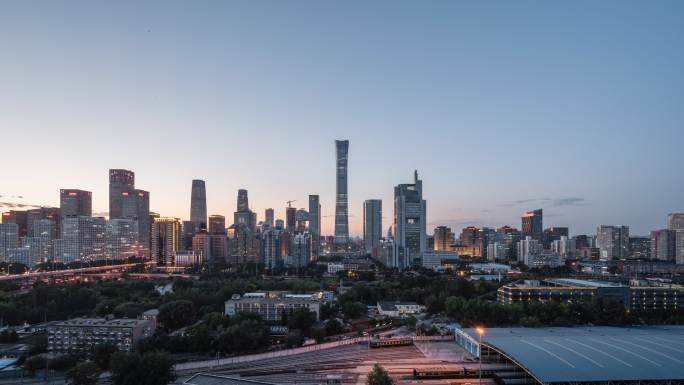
[392,171,427,269]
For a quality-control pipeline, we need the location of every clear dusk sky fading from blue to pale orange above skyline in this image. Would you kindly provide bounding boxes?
[0,0,684,235]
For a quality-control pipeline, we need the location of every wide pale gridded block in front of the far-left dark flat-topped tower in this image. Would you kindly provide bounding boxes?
[55,216,105,263]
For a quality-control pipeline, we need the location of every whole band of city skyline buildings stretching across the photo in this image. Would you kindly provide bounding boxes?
[0,140,684,270]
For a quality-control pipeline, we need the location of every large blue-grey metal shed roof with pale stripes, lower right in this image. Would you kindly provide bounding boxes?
[465,326,684,383]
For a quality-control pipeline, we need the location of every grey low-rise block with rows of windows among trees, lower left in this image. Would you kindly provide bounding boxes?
[47,318,155,355]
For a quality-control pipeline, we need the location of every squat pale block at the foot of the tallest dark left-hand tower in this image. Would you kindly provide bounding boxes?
[104,218,140,260]
